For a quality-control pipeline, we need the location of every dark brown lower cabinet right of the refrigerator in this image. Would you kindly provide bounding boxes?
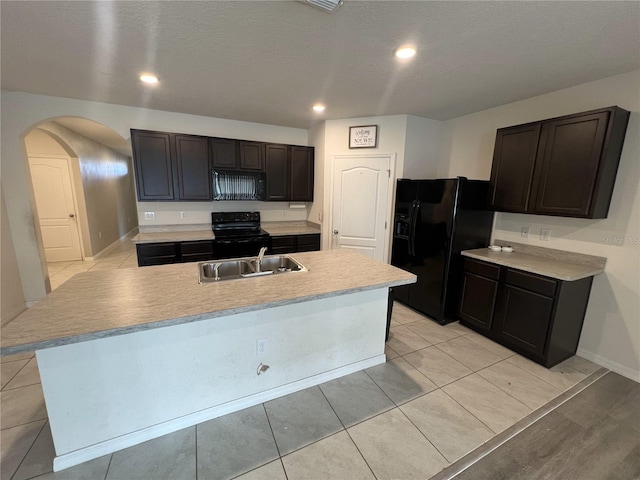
[459,258,593,368]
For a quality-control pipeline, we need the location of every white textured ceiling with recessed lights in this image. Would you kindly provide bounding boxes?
[0,0,640,141]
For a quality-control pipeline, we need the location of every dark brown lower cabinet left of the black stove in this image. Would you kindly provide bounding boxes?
[136,240,214,267]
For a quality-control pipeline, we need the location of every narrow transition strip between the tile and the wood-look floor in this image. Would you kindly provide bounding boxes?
[429,367,609,480]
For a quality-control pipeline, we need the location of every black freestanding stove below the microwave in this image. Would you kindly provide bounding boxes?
[211,212,271,258]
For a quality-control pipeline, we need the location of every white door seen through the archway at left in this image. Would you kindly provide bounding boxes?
[29,157,82,262]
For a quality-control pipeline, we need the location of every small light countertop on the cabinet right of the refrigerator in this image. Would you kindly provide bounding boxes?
[462,240,607,281]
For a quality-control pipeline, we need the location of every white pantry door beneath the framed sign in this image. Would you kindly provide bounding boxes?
[331,155,395,261]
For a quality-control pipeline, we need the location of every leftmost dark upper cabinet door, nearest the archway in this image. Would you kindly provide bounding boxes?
[131,130,174,200]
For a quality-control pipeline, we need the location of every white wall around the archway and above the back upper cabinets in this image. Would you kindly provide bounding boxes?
[0,90,307,302]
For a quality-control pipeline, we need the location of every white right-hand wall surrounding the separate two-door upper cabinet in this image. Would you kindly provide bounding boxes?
[444,71,640,380]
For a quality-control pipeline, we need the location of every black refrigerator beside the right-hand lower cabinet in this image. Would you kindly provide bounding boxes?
[391,177,493,324]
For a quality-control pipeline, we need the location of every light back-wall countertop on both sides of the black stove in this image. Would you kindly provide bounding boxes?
[131,222,320,244]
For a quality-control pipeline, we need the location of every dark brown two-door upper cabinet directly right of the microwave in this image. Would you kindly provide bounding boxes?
[265,143,314,202]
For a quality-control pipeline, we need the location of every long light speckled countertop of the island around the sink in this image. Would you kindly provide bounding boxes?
[0,249,416,355]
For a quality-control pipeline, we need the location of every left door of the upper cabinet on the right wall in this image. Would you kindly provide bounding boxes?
[489,123,540,213]
